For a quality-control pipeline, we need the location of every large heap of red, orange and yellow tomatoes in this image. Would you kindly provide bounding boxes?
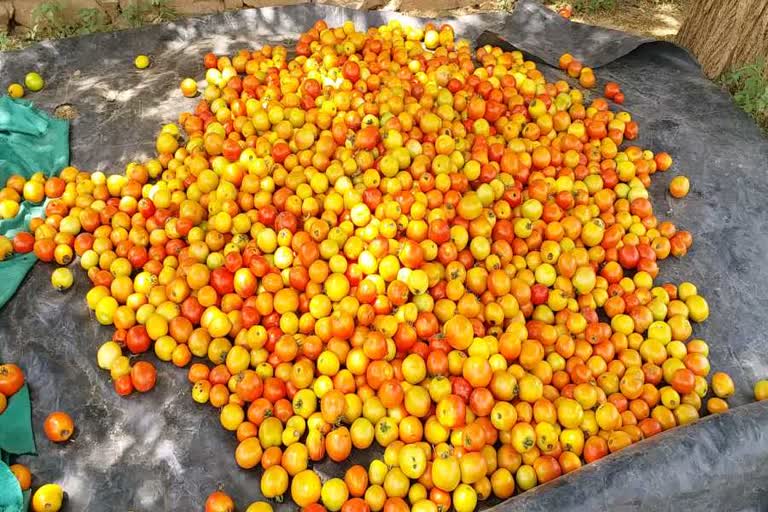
[0,16,768,512]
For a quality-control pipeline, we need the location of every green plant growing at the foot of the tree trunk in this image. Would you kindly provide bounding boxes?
[719,59,768,133]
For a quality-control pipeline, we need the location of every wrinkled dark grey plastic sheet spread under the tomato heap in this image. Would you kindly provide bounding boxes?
[0,0,768,512]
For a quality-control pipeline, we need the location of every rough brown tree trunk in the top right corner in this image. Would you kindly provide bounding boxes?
[677,0,768,78]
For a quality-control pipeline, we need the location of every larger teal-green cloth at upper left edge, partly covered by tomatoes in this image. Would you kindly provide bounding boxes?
[0,96,69,307]
